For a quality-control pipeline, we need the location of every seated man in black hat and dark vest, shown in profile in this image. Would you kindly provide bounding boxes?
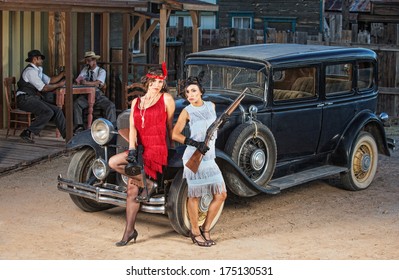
[17,50,66,143]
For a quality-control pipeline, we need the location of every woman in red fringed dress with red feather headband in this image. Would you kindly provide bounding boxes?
[109,64,175,246]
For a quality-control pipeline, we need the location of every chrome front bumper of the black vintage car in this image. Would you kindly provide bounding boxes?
[57,175,166,214]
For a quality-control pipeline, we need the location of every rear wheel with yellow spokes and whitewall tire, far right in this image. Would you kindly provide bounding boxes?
[341,131,378,191]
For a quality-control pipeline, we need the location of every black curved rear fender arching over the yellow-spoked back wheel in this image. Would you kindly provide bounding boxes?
[331,111,390,167]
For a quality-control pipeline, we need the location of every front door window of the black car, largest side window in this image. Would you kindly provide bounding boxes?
[273,67,317,101]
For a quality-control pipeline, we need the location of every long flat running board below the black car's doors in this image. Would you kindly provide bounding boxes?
[268,165,348,190]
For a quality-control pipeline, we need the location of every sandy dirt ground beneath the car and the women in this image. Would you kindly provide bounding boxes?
[0,127,399,260]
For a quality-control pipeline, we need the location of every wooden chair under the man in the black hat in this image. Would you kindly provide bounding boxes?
[4,77,32,138]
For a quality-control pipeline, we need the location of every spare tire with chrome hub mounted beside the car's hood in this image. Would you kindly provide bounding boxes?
[224,122,277,195]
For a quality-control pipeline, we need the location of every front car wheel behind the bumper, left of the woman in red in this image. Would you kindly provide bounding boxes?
[67,148,114,212]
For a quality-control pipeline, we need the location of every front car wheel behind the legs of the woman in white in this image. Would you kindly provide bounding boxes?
[166,169,224,236]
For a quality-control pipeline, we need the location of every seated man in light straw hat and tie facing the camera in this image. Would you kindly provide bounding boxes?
[73,51,116,133]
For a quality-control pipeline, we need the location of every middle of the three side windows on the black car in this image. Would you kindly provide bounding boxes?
[325,63,353,96]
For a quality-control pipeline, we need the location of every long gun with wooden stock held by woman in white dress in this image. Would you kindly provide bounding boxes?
[186,88,249,173]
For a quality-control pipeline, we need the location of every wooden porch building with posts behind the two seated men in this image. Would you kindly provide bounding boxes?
[0,0,218,139]
